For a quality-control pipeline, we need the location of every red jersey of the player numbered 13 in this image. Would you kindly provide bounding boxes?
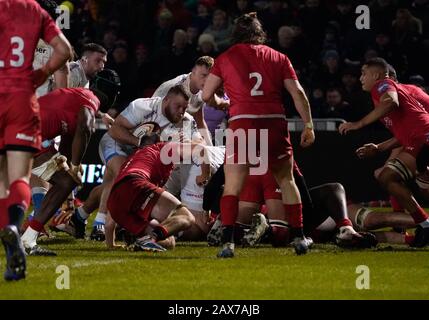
[0,0,59,92]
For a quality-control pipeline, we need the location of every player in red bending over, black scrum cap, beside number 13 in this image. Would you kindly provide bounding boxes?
[22,74,117,255]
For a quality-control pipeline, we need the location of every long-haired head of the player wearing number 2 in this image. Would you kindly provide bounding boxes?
[232,12,267,44]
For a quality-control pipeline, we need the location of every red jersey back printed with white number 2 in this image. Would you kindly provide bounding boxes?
[213,44,296,116]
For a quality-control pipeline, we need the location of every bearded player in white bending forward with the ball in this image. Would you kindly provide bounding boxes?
[68,86,203,240]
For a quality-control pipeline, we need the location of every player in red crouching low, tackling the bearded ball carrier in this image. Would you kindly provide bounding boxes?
[106,122,211,251]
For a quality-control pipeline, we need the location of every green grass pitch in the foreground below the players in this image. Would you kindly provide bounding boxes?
[0,234,429,299]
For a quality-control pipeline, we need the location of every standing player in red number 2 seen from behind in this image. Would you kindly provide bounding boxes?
[203,13,314,258]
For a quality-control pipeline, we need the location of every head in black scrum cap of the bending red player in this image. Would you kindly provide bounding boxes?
[90,69,121,112]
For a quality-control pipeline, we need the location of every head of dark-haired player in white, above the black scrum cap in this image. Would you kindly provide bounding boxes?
[80,43,107,79]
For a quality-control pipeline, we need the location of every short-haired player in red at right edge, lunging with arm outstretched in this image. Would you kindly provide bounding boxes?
[339,58,429,247]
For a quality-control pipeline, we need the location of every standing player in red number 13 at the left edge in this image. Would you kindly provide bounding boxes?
[0,0,71,280]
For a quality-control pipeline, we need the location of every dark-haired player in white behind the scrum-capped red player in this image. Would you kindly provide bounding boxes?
[69,43,107,88]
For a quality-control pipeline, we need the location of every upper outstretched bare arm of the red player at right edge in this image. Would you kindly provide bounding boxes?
[338,91,399,134]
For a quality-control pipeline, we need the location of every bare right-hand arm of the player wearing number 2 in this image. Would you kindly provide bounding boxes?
[284,79,315,148]
